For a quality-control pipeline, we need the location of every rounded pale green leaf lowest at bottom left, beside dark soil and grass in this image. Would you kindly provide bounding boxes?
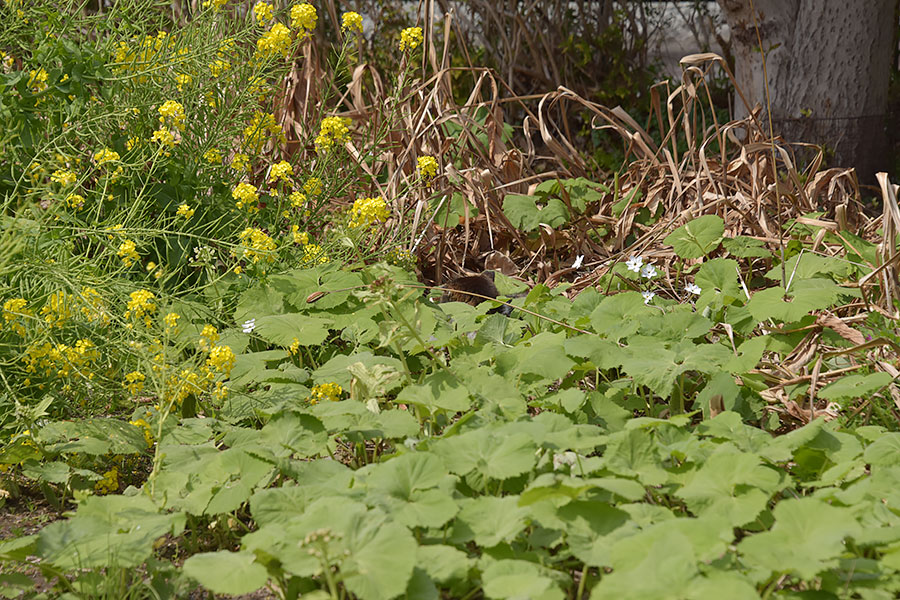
[182,550,269,595]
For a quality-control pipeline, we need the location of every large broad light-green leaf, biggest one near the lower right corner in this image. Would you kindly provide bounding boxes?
[738,498,859,580]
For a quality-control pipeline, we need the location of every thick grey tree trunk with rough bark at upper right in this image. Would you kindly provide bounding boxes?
[718,0,897,183]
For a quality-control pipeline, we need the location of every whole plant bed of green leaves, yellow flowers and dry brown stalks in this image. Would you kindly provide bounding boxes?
[0,0,900,600]
